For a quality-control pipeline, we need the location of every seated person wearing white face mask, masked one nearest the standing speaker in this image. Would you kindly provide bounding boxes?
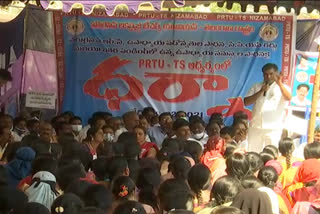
[190,116,209,146]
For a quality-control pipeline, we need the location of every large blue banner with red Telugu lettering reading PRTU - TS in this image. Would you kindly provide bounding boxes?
[54,11,293,123]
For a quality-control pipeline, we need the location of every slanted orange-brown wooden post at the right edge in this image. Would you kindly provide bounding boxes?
[308,45,320,143]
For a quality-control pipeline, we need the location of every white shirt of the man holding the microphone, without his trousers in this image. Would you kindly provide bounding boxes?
[246,82,289,130]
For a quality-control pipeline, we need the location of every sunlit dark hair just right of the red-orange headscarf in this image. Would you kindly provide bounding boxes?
[226,153,250,181]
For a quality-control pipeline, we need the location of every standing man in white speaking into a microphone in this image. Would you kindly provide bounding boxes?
[244,63,291,152]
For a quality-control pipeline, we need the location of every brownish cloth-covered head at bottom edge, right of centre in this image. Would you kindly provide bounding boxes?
[231,189,272,214]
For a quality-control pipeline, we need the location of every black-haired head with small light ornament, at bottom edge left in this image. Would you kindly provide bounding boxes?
[51,193,84,214]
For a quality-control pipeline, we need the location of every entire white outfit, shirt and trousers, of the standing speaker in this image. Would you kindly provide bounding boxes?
[246,82,286,152]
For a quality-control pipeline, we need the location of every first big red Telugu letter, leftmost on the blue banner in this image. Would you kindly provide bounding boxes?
[83,56,143,110]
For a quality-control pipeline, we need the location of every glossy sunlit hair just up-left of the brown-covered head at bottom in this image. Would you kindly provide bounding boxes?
[210,176,241,205]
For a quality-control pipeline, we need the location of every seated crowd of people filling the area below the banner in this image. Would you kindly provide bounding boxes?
[0,107,320,214]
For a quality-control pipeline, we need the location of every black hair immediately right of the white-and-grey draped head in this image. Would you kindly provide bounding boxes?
[57,162,86,191]
